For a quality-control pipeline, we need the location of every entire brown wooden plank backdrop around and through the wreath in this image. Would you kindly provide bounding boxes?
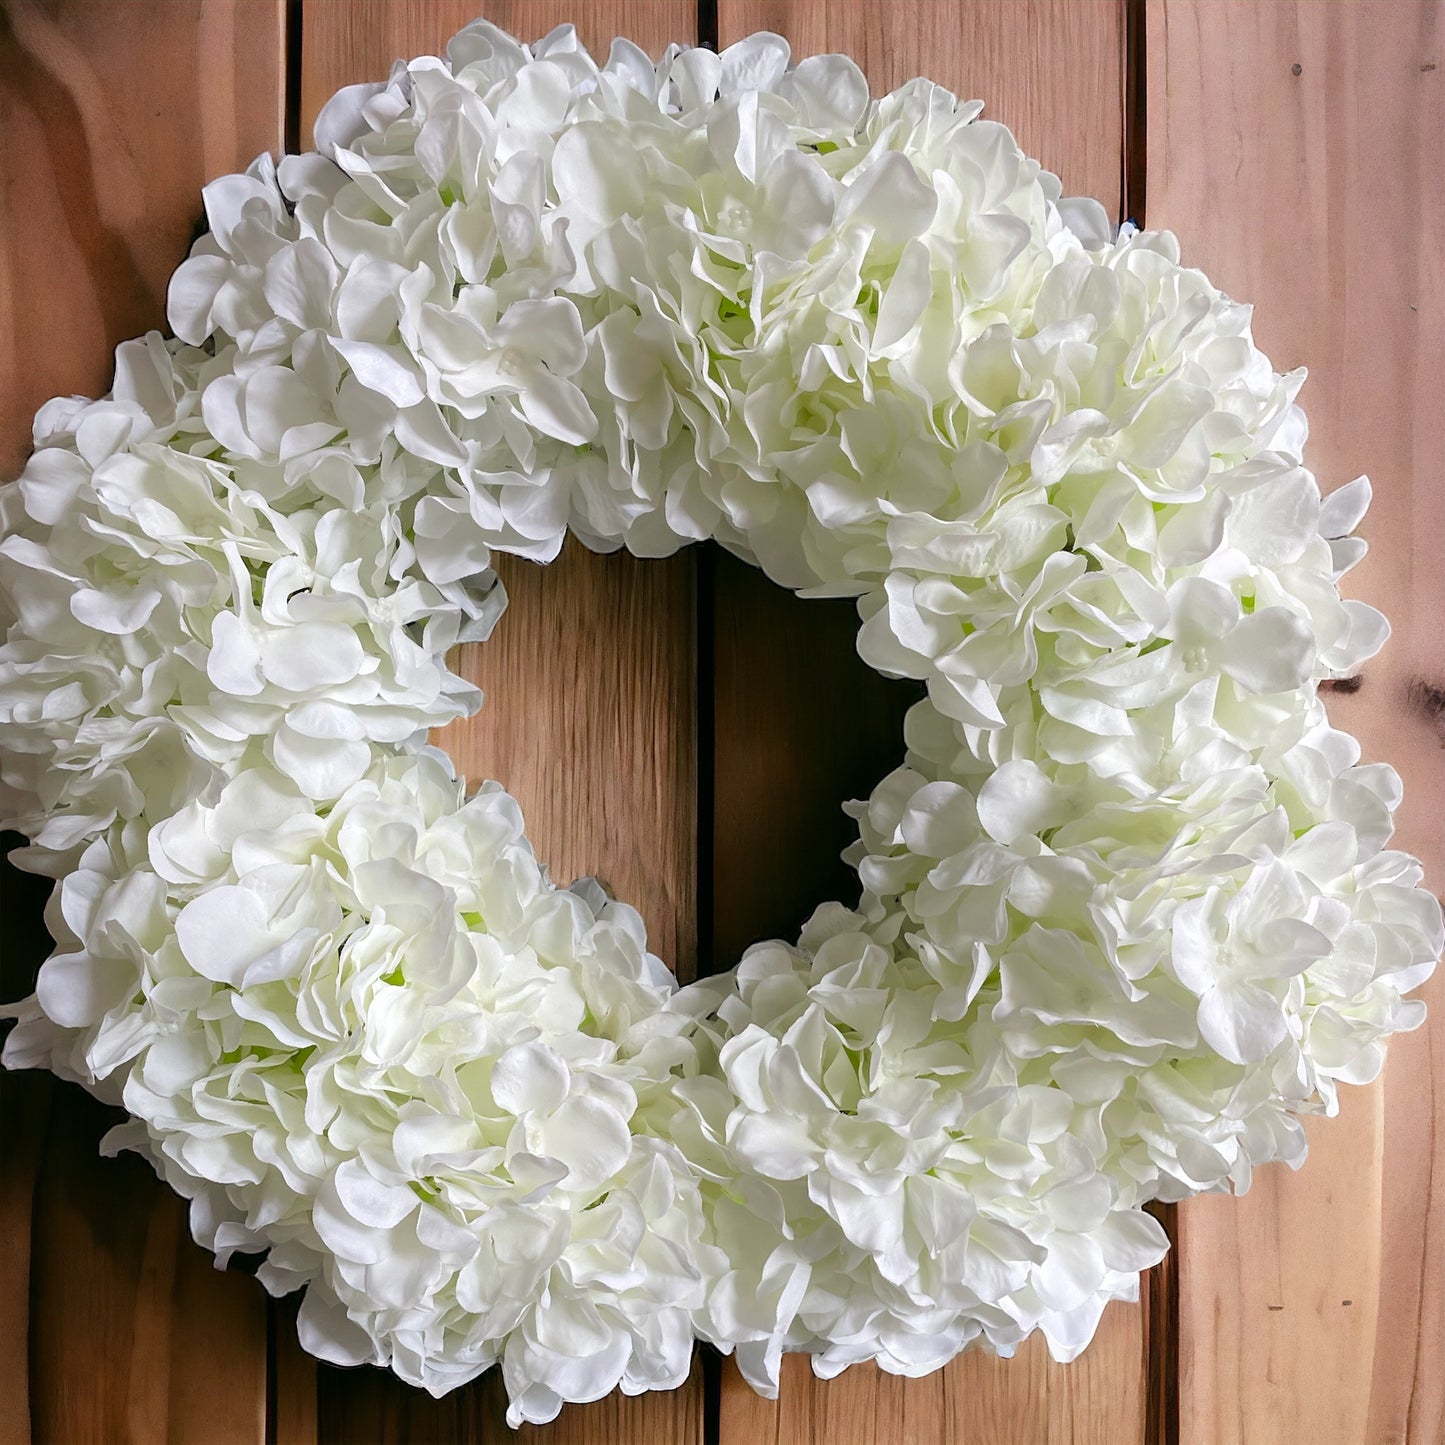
[0,0,1445,1445]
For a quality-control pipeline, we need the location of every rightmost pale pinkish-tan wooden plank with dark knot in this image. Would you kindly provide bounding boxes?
[1144,0,1445,1445]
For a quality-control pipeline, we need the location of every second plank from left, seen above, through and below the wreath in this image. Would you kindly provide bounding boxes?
[301,0,702,1445]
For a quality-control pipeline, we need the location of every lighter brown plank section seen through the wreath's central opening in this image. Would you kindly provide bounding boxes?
[436,539,696,978]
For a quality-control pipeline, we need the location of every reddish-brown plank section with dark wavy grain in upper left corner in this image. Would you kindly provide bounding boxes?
[0,0,285,477]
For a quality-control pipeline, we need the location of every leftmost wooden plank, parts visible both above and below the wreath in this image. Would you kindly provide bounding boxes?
[0,0,285,1442]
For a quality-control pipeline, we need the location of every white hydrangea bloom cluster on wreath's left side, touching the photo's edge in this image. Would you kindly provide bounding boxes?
[0,335,501,876]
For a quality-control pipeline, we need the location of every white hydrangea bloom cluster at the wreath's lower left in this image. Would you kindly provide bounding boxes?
[10,753,715,1419]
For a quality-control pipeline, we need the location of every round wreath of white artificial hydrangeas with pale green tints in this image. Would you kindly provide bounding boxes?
[0,16,1441,1423]
